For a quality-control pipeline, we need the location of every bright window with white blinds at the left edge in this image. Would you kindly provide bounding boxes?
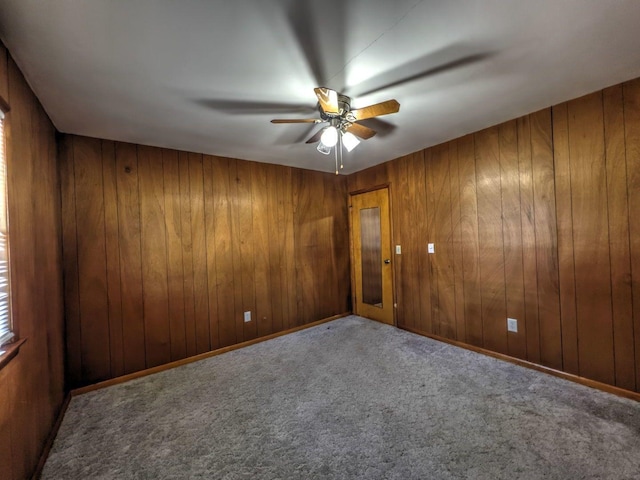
[0,110,14,346]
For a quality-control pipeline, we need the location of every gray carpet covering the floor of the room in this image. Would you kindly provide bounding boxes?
[43,316,640,480]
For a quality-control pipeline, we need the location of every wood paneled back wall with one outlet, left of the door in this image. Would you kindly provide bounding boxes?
[60,135,350,386]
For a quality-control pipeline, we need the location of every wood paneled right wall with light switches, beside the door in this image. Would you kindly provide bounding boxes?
[349,80,640,391]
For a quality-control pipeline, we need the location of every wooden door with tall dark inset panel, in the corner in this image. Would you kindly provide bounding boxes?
[350,188,394,325]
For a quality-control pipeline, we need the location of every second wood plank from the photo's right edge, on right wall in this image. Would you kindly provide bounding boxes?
[603,85,636,390]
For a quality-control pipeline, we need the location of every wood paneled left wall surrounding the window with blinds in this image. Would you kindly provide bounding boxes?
[0,44,64,479]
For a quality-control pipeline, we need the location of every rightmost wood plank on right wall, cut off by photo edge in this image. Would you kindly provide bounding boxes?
[623,79,640,391]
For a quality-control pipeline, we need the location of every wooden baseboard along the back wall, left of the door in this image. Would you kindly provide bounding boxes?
[71,312,351,396]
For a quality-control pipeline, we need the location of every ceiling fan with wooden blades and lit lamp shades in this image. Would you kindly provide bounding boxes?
[271,87,400,174]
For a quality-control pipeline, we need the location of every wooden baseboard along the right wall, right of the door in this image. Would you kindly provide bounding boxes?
[398,325,640,402]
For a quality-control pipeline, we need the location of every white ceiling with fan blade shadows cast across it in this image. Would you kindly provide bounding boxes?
[0,0,640,172]
